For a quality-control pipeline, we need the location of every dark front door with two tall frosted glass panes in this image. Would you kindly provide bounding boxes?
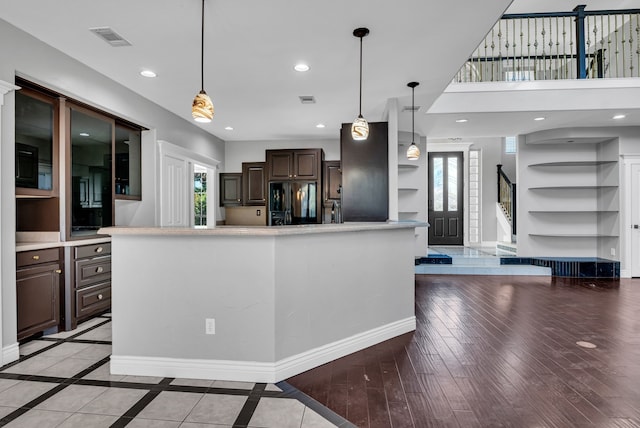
[428,152,464,245]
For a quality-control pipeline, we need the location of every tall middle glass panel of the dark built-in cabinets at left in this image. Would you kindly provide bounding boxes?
[69,109,113,236]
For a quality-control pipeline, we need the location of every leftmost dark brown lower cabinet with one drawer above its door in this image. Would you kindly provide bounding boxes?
[16,248,62,340]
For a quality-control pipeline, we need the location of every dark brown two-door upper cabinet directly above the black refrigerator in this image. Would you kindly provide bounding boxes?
[266,149,323,181]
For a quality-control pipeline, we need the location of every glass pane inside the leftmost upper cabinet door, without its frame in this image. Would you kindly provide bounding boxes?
[15,91,54,190]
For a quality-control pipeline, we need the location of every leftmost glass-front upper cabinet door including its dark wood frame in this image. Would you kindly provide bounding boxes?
[15,89,58,196]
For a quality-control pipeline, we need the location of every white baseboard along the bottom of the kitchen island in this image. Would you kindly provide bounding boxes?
[111,316,416,383]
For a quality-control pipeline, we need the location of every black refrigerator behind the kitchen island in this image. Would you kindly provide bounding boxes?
[269,181,318,226]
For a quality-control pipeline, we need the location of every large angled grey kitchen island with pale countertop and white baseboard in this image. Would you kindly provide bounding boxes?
[100,222,426,382]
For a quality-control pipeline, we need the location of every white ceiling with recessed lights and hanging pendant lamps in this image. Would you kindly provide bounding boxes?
[0,0,640,144]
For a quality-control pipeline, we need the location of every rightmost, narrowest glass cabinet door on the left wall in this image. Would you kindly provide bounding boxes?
[114,124,142,197]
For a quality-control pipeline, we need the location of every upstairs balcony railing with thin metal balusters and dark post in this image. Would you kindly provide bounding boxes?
[454,5,640,82]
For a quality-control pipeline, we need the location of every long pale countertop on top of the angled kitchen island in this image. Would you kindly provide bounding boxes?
[98,221,428,236]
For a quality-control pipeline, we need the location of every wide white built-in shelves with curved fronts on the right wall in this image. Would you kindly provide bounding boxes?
[517,136,620,259]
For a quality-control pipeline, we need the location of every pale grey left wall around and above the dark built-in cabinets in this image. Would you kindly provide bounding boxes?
[0,20,225,354]
